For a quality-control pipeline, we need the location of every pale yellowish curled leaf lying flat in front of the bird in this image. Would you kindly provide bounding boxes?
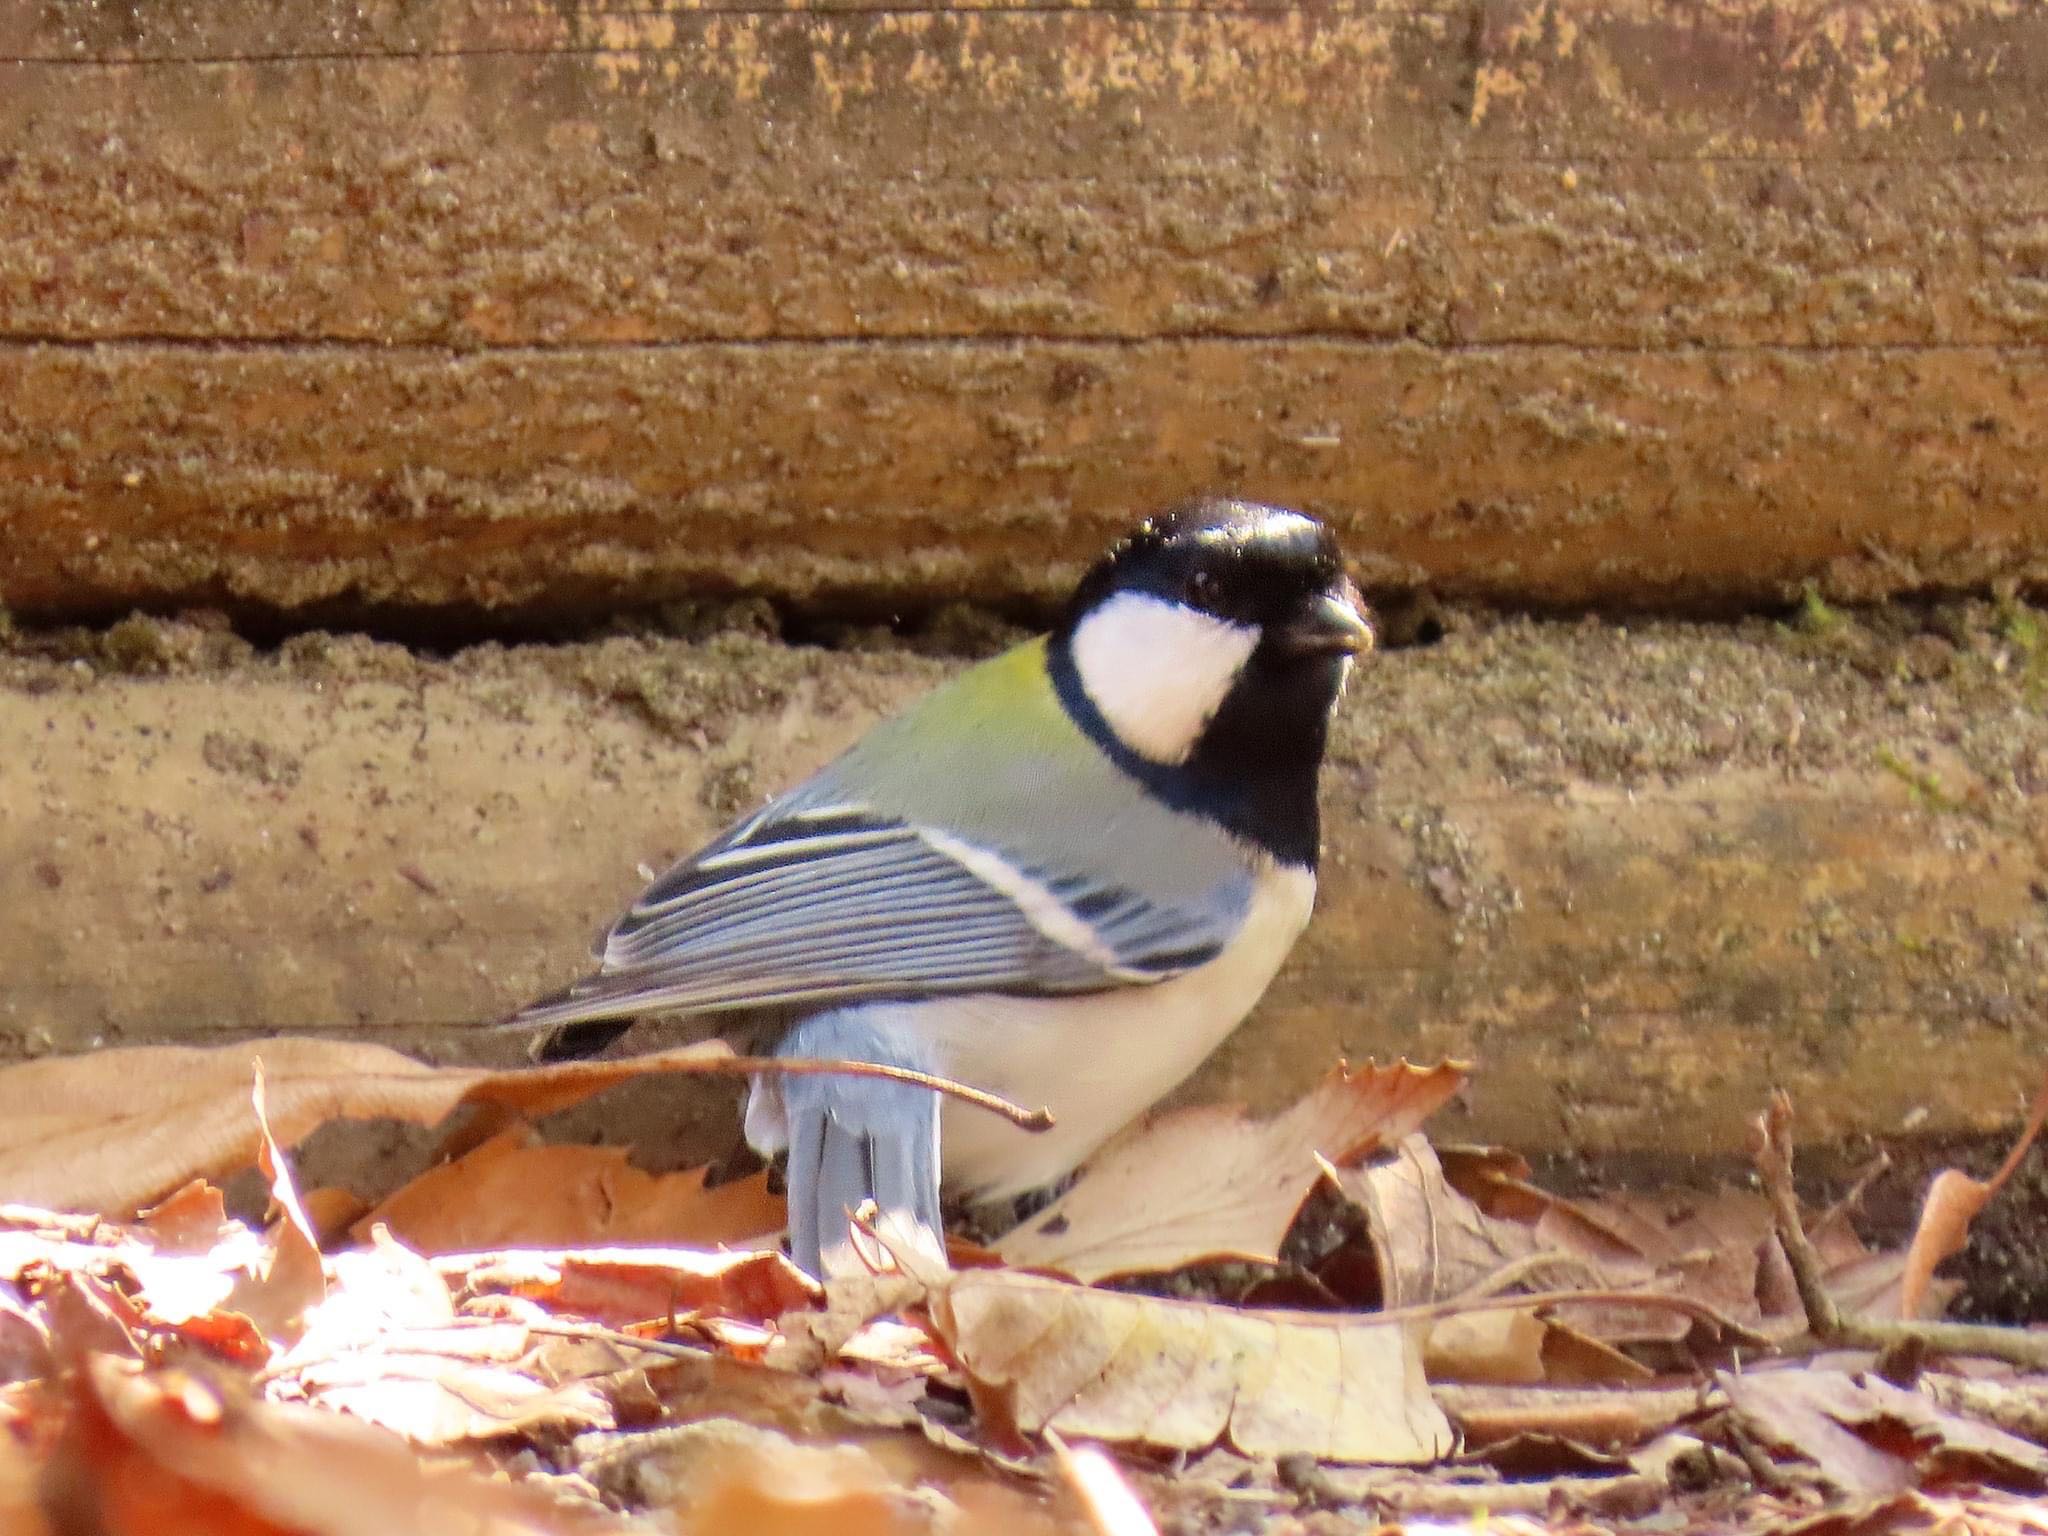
[932,1270,1450,1462]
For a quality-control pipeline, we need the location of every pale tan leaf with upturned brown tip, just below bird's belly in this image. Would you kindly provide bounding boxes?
[995,1061,1466,1280]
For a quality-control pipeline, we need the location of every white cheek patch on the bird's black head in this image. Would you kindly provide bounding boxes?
[1073,592,1260,764]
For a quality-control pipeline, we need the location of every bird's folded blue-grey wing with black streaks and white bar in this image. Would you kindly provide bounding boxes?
[512,799,1251,1024]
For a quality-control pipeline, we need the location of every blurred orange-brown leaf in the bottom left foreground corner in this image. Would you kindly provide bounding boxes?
[41,1356,621,1536]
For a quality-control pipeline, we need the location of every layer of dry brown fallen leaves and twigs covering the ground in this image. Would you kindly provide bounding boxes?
[0,1042,2048,1536]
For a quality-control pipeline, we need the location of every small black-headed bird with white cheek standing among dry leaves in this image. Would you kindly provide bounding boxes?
[508,498,1374,1278]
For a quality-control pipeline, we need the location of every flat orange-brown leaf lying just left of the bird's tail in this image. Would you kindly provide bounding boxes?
[354,1128,784,1253]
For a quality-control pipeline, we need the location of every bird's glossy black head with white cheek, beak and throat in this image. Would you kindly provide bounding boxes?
[1051,500,1372,864]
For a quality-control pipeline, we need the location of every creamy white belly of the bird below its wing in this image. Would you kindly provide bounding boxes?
[909,866,1315,1198]
